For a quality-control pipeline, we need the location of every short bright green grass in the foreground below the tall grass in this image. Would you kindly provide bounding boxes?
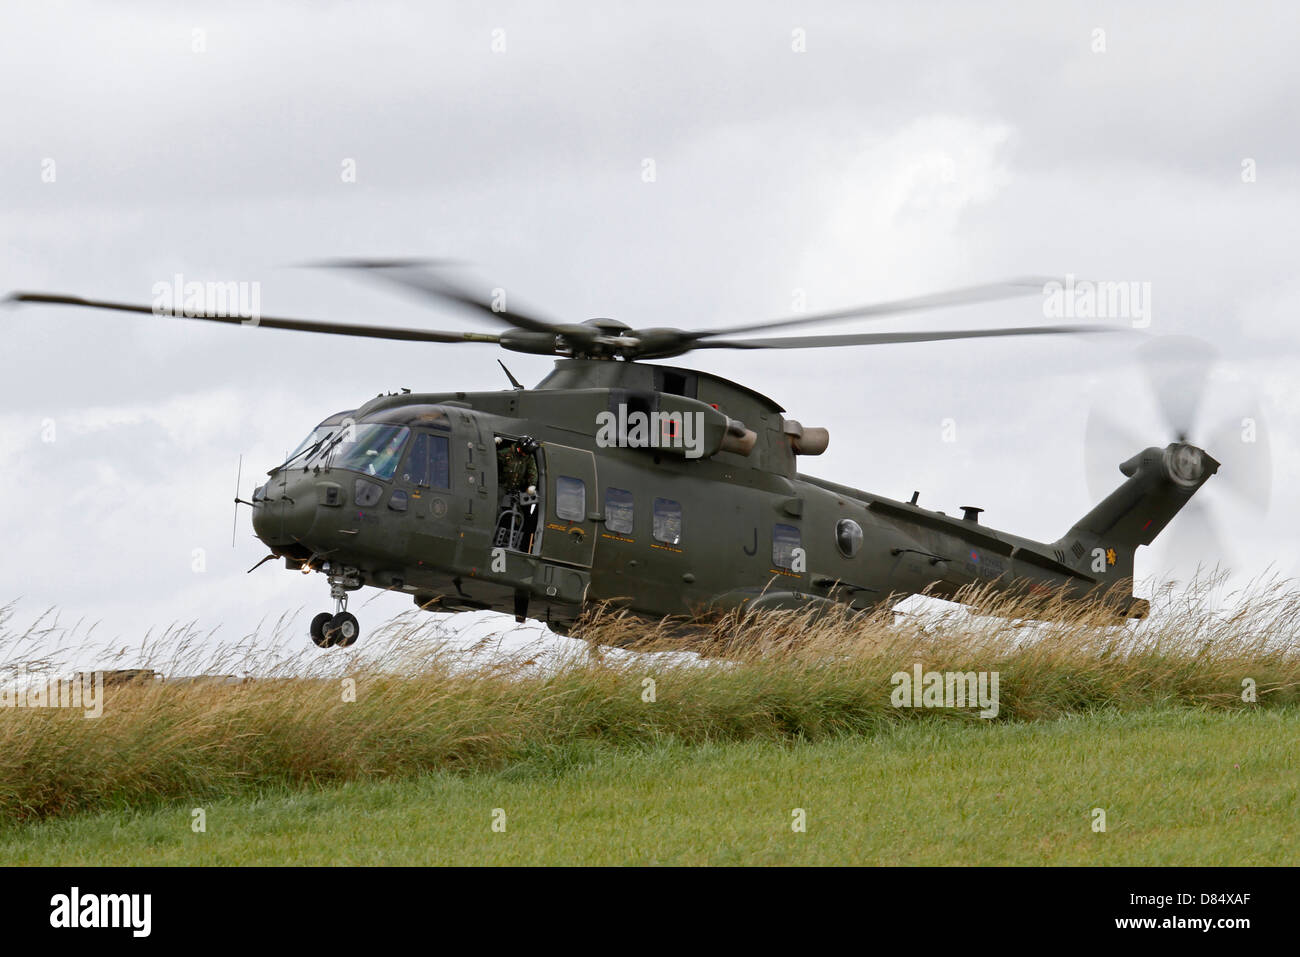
[0,706,1300,865]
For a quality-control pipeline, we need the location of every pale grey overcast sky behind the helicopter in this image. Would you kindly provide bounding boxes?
[0,3,1300,670]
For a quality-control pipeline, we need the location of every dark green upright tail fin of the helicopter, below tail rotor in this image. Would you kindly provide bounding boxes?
[1052,442,1219,590]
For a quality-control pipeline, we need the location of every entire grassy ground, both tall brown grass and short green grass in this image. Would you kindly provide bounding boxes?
[0,584,1300,865]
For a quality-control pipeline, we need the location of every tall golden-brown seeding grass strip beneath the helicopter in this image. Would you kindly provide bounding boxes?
[0,572,1300,822]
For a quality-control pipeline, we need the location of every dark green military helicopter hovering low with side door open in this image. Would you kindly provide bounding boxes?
[10,260,1248,648]
